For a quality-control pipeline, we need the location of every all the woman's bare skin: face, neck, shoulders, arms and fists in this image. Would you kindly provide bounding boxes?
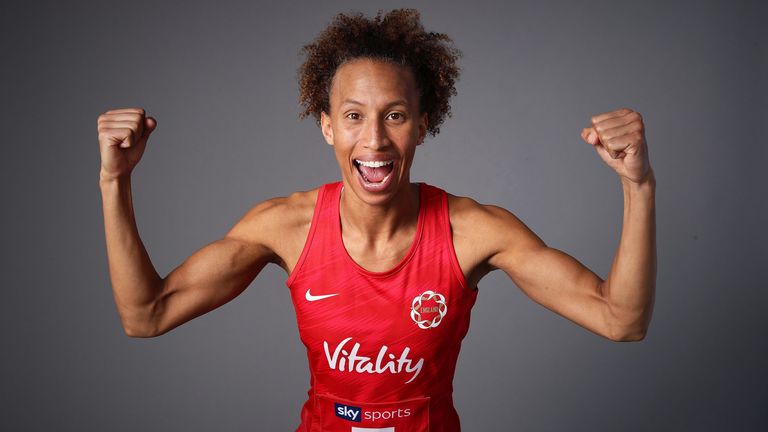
[98,59,656,341]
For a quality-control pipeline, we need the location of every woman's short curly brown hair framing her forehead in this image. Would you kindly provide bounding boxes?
[298,9,461,136]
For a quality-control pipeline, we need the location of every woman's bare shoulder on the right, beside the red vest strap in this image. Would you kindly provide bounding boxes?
[447,193,543,277]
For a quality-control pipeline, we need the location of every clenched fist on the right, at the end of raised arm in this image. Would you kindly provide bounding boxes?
[581,108,651,183]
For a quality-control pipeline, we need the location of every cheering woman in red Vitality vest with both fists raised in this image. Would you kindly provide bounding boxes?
[98,10,656,431]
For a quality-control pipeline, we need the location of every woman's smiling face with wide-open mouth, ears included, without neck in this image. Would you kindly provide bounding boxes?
[321,59,427,204]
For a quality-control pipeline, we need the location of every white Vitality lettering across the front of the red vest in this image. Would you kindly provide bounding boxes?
[323,337,424,384]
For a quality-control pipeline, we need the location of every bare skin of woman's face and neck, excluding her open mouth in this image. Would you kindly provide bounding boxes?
[321,59,427,271]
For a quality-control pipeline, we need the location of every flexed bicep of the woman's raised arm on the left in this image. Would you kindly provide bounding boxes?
[153,201,274,335]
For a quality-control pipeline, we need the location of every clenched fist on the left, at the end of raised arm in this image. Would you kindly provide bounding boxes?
[97,108,157,179]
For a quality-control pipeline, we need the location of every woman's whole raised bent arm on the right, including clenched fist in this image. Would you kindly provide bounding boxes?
[472,108,656,341]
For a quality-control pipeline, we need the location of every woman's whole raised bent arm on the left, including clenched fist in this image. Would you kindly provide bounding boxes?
[98,109,281,337]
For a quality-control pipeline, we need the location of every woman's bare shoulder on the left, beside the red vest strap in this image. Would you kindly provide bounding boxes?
[227,187,320,271]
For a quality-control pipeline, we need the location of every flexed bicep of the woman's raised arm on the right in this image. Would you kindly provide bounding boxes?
[489,209,610,337]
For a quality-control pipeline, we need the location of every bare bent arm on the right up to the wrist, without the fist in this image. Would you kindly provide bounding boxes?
[474,169,656,341]
